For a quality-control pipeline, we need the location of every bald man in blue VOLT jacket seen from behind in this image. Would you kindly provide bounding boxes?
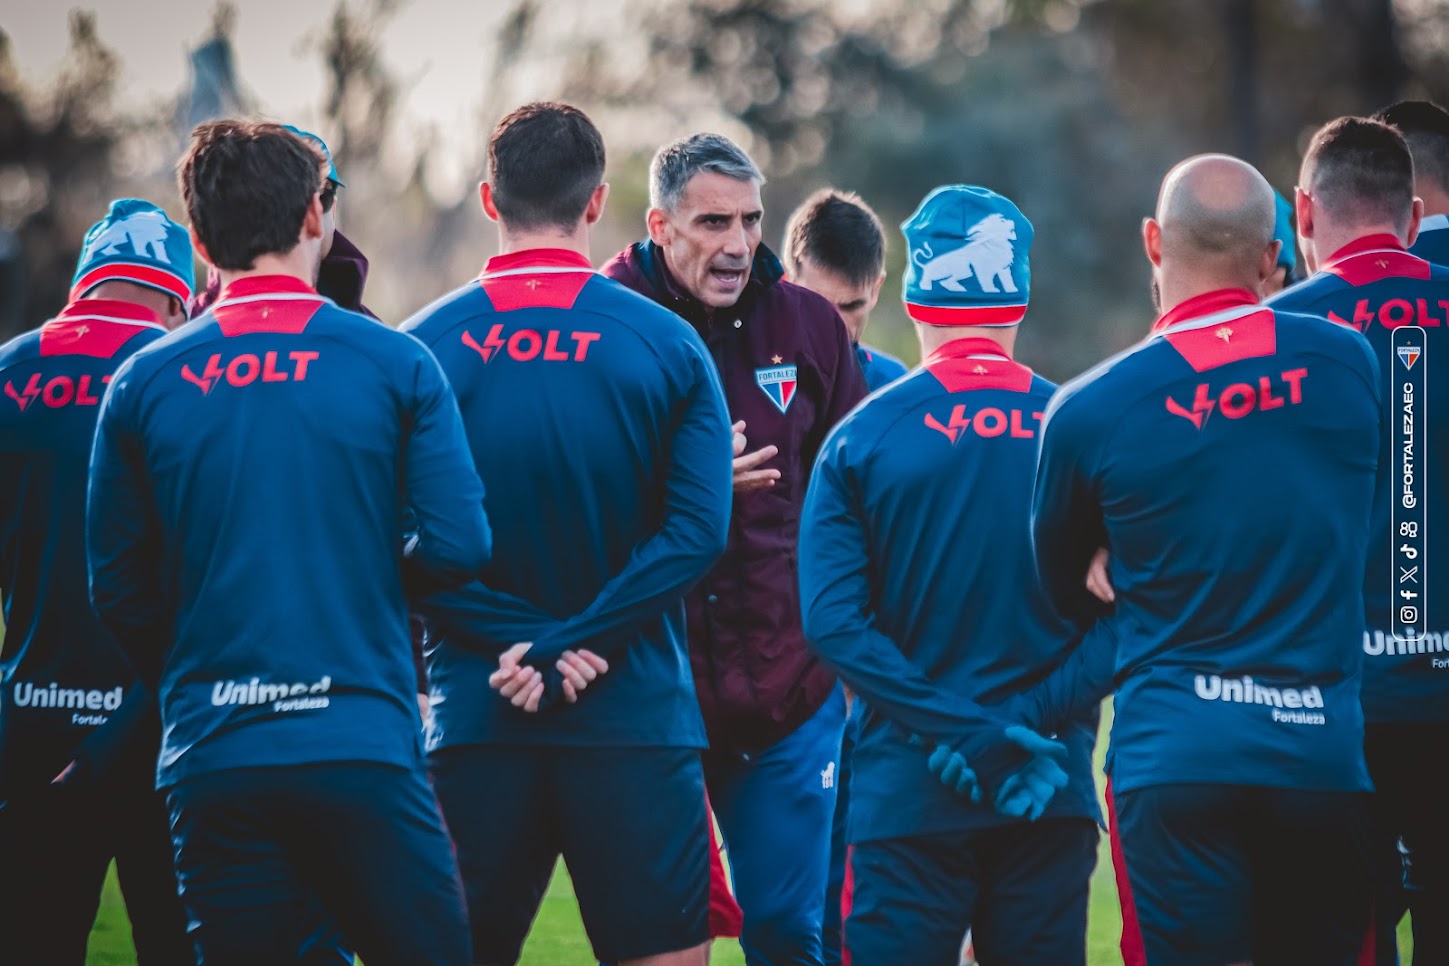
[1022,155,1381,966]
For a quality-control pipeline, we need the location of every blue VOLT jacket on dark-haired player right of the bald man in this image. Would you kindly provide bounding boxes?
[1269,230,1449,723]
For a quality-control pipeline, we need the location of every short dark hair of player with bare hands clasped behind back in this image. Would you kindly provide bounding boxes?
[488,101,604,230]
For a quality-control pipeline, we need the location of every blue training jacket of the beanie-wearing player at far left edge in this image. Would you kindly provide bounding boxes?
[0,298,167,801]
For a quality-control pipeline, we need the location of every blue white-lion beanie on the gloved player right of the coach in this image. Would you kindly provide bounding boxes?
[901,184,1033,326]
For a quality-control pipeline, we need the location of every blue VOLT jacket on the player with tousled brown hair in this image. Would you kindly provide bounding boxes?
[88,277,490,786]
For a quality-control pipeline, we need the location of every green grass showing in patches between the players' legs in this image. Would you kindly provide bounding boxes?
[85,705,1413,966]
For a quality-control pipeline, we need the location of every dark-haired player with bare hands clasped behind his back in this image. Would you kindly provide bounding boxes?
[404,103,732,966]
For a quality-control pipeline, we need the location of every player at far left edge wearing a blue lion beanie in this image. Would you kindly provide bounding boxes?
[0,198,196,966]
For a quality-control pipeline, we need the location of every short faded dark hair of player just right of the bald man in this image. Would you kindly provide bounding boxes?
[1303,117,1414,230]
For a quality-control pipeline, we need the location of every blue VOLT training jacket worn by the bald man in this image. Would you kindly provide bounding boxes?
[1032,290,1381,792]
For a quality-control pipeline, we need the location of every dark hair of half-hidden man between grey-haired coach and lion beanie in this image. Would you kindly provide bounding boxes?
[785,188,885,285]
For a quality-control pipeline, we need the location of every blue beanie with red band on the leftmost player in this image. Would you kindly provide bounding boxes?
[71,198,196,304]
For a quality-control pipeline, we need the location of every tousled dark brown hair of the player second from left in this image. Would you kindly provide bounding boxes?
[177,120,326,271]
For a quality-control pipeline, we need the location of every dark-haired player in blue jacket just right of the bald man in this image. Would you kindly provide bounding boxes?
[1269,117,1449,966]
